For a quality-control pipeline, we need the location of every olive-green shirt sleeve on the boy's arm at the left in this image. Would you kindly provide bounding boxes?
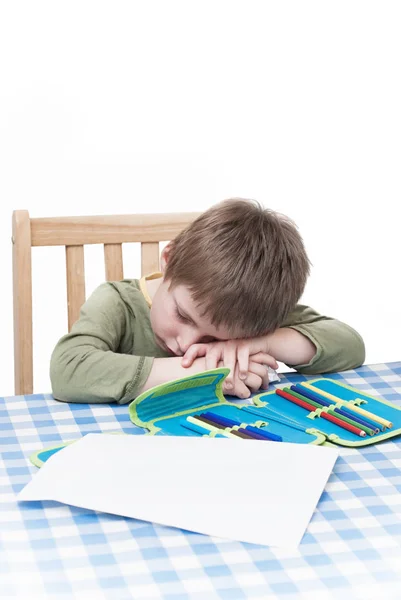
[50,284,153,404]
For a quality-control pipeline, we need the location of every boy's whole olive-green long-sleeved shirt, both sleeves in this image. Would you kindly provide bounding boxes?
[50,279,365,404]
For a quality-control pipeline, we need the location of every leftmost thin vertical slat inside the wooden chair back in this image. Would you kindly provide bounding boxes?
[65,246,85,331]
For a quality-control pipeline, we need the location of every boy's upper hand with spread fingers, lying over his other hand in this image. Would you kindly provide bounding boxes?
[181,336,278,395]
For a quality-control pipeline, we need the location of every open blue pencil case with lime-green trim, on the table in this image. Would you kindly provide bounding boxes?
[30,367,401,467]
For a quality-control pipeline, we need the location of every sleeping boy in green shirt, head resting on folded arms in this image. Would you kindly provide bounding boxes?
[50,199,365,404]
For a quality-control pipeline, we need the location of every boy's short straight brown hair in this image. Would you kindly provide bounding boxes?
[165,198,310,337]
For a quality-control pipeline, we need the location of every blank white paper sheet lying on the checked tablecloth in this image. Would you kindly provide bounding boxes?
[18,434,338,548]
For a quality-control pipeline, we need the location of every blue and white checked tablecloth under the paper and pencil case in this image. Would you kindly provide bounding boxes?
[0,363,401,600]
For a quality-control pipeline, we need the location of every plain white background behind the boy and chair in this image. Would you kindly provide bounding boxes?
[0,0,401,395]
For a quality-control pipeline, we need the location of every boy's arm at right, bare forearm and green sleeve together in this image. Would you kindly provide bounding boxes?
[276,304,365,374]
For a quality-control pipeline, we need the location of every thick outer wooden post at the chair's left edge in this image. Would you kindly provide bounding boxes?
[12,210,33,395]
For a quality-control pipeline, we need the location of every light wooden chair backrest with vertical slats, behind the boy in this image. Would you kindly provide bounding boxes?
[12,210,199,395]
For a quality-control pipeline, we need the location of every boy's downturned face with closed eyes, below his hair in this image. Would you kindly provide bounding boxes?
[150,279,231,356]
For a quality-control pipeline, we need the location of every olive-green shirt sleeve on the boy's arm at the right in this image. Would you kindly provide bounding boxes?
[282,304,365,374]
